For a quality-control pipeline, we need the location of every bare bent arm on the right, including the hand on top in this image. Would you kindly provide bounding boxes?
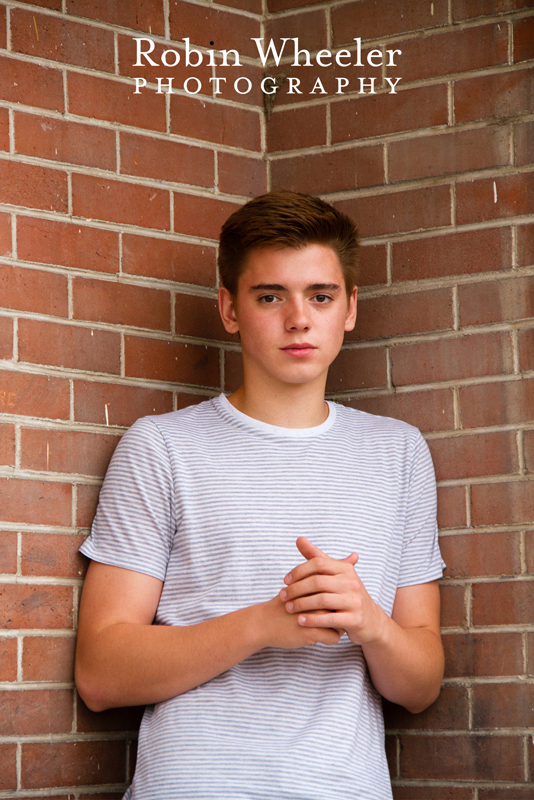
[280,537,443,713]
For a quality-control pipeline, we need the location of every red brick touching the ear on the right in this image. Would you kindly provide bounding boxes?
[352,289,454,340]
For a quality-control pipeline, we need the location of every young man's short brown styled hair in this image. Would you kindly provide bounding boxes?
[219,190,358,297]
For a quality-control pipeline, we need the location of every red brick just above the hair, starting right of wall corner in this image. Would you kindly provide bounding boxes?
[271,146,384,194]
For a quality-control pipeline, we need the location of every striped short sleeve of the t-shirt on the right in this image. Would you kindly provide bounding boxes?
[398,434,445,587]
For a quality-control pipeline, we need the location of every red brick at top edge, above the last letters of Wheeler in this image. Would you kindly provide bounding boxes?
[332,0,448,48]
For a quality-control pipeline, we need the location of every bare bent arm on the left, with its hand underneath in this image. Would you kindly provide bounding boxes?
[75,561,341,711]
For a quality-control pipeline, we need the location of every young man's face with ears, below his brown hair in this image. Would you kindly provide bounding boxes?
[219,244,357,387]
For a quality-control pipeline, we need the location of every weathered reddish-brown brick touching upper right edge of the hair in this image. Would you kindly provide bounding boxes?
[334,186,451,237]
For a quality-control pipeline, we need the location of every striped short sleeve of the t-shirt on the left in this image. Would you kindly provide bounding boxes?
[80,417,176,580]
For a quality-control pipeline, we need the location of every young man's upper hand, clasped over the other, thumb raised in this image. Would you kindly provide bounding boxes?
[280,536,387,645]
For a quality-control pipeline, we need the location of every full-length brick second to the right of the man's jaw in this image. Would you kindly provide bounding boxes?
[391,333,513,386]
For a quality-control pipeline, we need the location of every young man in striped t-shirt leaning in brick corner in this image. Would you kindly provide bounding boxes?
[77,192,443,800]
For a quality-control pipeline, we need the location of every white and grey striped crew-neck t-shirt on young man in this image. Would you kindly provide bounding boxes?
[82,395,443,800]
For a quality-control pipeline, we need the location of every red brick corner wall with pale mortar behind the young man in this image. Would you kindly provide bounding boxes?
[0,0,534,800]
